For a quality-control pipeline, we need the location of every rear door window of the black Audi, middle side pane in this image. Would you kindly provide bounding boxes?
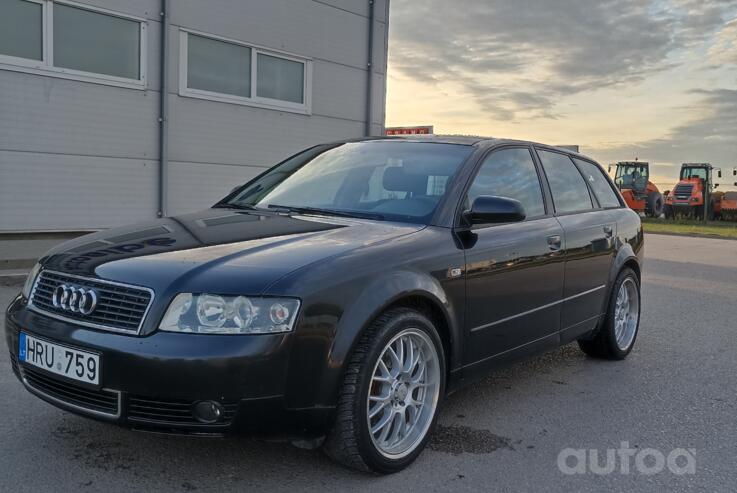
[537,150,593,213]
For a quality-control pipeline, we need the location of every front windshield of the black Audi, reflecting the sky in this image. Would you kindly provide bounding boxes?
[221,140,473,224]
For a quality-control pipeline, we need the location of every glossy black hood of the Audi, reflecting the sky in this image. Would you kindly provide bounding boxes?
[41,209,424,294]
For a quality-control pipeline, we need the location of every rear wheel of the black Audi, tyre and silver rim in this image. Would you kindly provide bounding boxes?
[578,267,641,360]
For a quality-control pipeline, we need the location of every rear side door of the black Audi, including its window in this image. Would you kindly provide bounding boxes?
[537,149,621,342]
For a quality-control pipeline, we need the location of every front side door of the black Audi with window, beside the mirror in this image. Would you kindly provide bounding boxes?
[464,146,563,370]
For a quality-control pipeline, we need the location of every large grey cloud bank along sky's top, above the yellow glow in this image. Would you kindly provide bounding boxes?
[389,0,734,120]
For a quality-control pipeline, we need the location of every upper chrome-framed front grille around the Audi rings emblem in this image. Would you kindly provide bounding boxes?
[31,270,153,334]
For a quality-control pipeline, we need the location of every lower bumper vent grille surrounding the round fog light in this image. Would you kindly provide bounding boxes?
[128,396,238,426]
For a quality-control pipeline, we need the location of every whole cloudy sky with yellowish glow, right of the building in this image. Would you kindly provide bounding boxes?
[386,0,737,184]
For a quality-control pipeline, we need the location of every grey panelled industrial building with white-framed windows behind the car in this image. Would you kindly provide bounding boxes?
[0,0,389,233]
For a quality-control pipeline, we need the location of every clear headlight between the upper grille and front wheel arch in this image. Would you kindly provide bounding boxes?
[159,293,299,334]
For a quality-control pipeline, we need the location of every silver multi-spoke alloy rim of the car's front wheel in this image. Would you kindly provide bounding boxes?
[366,329,440,459]
